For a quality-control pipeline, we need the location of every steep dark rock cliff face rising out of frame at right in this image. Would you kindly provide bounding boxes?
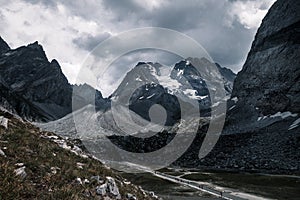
[232,0,300,115]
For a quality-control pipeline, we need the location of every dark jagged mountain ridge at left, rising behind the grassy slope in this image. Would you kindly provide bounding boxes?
[0,39,109,121]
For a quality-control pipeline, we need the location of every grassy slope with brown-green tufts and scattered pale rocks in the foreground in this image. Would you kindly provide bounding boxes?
[0,111,155,200]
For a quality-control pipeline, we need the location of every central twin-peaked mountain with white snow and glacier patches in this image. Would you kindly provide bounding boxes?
[111,58,235,125]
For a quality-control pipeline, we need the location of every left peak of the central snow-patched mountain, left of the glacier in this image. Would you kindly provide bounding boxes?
[111,62,180,125]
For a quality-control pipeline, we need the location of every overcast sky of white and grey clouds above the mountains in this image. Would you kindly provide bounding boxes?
[0,0,275,96]
